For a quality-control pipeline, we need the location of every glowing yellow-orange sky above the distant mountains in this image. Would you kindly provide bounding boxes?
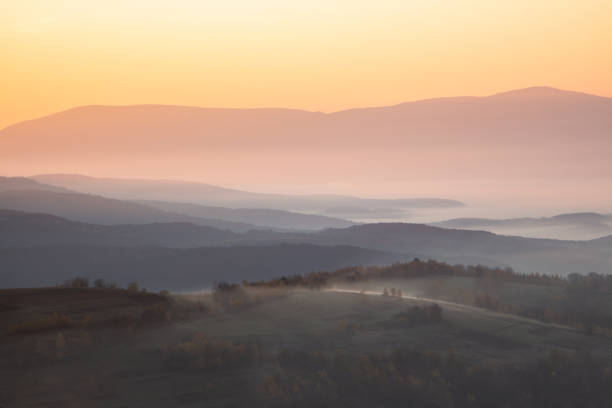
[0,0,612,128]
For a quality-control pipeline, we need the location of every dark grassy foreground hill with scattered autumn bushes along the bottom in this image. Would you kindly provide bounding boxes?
[0,286,612,408]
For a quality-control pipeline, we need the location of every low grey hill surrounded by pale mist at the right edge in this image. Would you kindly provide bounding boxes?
[431,213,612,239]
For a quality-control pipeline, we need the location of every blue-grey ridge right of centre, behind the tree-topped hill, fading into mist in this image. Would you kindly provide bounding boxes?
[245,223,612,275]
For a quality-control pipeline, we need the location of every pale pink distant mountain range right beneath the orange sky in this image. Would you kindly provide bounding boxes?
[0,87,612,209]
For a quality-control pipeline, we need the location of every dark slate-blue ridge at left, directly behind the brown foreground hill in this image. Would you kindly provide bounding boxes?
[0,244,403,290]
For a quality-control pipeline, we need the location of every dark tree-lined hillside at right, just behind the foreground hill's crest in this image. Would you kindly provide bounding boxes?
[243,258,612,337]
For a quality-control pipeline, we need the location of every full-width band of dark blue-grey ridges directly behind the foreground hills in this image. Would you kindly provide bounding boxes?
[0,210,612,289]
